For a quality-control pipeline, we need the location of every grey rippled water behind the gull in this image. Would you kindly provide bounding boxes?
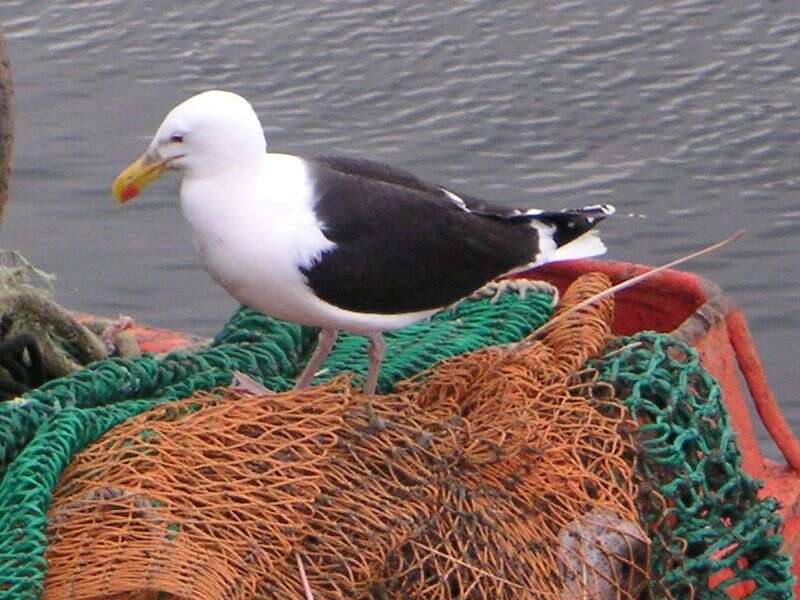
[0,0,800,450]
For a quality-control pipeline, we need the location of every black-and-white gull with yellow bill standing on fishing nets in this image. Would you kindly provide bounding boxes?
[112,90,614,394]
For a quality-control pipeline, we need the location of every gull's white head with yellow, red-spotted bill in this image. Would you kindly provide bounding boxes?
[112,90,267,204]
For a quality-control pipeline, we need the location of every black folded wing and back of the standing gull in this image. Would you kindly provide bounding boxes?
[304,157,538,314]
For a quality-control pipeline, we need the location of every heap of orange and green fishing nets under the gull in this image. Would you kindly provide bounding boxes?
[0,276,793,600]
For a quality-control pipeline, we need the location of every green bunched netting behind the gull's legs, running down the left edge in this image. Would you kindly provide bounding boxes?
[0,293,553,600]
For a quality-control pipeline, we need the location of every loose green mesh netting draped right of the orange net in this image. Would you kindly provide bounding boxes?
[592,333,794,600]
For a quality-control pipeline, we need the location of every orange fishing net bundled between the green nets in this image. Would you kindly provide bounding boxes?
[44,274,649,600]
